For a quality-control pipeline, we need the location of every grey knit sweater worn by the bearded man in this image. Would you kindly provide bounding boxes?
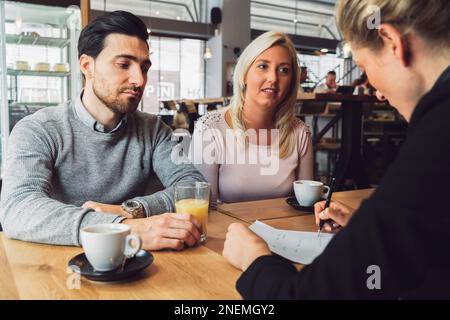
[0,103,204,245]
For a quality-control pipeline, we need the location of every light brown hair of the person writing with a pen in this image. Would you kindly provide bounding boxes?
[336,0,450,51]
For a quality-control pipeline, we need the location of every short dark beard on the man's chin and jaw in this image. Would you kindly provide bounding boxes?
[92,80,142,114]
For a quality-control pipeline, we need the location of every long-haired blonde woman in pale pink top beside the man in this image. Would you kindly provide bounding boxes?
[190,31,313,202]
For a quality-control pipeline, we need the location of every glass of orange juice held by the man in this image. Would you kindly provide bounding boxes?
[175,181,210,242]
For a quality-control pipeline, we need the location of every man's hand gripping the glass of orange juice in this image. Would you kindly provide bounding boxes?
[122,213,202,250]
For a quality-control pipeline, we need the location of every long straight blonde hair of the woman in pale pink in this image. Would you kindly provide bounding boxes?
[229,31,300,158]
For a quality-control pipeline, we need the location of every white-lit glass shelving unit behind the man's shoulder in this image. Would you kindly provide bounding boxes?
[0,0,81,171]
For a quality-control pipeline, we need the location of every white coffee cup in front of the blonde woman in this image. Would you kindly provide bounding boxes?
[294,180,330,207]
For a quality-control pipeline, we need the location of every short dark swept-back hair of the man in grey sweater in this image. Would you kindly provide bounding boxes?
[78,11,148,59]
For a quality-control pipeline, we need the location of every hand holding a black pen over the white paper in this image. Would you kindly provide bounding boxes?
[314,201,355,232]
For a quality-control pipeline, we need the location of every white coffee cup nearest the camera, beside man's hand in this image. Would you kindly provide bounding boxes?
[80,223,142,271]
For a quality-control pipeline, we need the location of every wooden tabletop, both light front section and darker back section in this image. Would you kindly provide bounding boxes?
[0,189,373,300]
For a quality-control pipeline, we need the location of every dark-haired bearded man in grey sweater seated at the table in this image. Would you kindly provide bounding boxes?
[0,11,204,250]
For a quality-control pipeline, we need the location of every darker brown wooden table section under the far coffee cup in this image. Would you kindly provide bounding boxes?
[217,189,374,223]
